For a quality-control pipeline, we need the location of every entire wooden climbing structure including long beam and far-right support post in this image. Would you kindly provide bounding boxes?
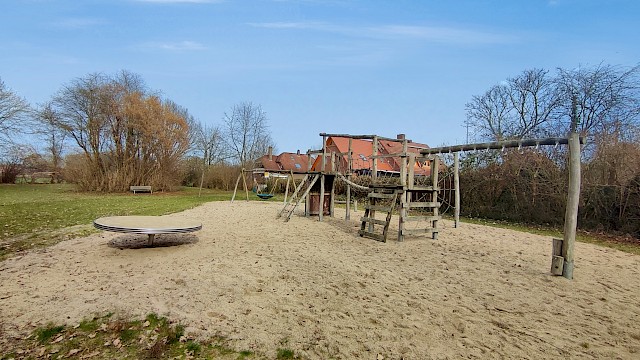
[232,129,584,279]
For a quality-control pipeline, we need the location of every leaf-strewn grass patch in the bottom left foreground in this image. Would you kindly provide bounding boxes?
[0,313,266,360]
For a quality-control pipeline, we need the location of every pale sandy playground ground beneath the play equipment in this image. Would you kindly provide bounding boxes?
[0,201,640,359]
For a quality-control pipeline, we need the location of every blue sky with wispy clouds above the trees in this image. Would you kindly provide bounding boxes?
[0,0,640,151]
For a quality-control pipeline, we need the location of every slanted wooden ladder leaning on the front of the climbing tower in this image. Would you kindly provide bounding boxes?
[358,187,398,242]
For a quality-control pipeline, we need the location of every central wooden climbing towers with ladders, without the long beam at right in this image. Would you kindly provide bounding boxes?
[278,133,440,242]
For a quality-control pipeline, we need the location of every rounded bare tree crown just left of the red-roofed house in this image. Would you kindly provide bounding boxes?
[223,102,273,167]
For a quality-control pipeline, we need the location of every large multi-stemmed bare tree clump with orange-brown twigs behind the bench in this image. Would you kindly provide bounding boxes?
[52,71,190,191]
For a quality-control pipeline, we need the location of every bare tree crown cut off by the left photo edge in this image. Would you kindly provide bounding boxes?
[0,79,30,146]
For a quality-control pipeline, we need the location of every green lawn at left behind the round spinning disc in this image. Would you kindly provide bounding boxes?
[0,184,231,261]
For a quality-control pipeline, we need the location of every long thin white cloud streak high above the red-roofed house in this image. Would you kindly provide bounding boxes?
[249,22,517,44]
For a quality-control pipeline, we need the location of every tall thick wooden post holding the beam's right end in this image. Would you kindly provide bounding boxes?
[562,131,580,279]
